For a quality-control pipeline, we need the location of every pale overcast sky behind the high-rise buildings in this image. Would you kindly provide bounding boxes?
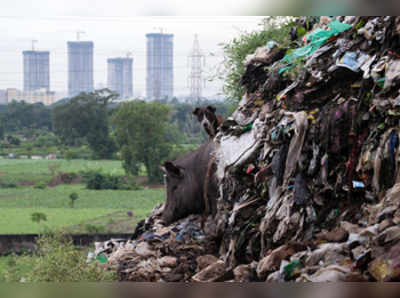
[0,0,262,96]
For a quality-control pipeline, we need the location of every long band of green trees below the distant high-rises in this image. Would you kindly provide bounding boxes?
[0,89,232,183]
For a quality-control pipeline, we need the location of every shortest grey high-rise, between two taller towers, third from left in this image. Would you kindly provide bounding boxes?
[107,58,133,99]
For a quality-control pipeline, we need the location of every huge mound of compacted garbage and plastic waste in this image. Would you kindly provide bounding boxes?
[96,17,400,282]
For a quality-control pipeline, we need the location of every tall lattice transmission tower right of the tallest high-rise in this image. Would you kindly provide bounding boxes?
[188,34,206,103]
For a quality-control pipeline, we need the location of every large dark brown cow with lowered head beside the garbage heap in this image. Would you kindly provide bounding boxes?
[161,141,218,224]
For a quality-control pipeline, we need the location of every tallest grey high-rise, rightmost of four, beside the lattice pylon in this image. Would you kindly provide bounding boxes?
[146,33,174,100]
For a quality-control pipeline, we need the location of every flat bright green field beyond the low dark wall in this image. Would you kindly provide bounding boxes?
[0,159,165,234]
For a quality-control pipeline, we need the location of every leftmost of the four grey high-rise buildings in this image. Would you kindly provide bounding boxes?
[22,51,50,91]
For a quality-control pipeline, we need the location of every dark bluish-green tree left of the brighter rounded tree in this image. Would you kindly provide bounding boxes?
[52,89,117,159]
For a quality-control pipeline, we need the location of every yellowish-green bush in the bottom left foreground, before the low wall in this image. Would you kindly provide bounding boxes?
[6,234,116,282]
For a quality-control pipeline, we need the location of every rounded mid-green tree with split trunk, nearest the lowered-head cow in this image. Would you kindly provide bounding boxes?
[112,100,177,183]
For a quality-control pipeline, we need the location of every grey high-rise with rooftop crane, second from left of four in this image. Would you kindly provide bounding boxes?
[68,41,93,96]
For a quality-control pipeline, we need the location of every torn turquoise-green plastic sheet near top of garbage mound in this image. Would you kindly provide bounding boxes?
[279,20,352,74]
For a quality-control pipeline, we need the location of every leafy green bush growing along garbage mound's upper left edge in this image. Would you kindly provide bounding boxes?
[218,17,292,103]
